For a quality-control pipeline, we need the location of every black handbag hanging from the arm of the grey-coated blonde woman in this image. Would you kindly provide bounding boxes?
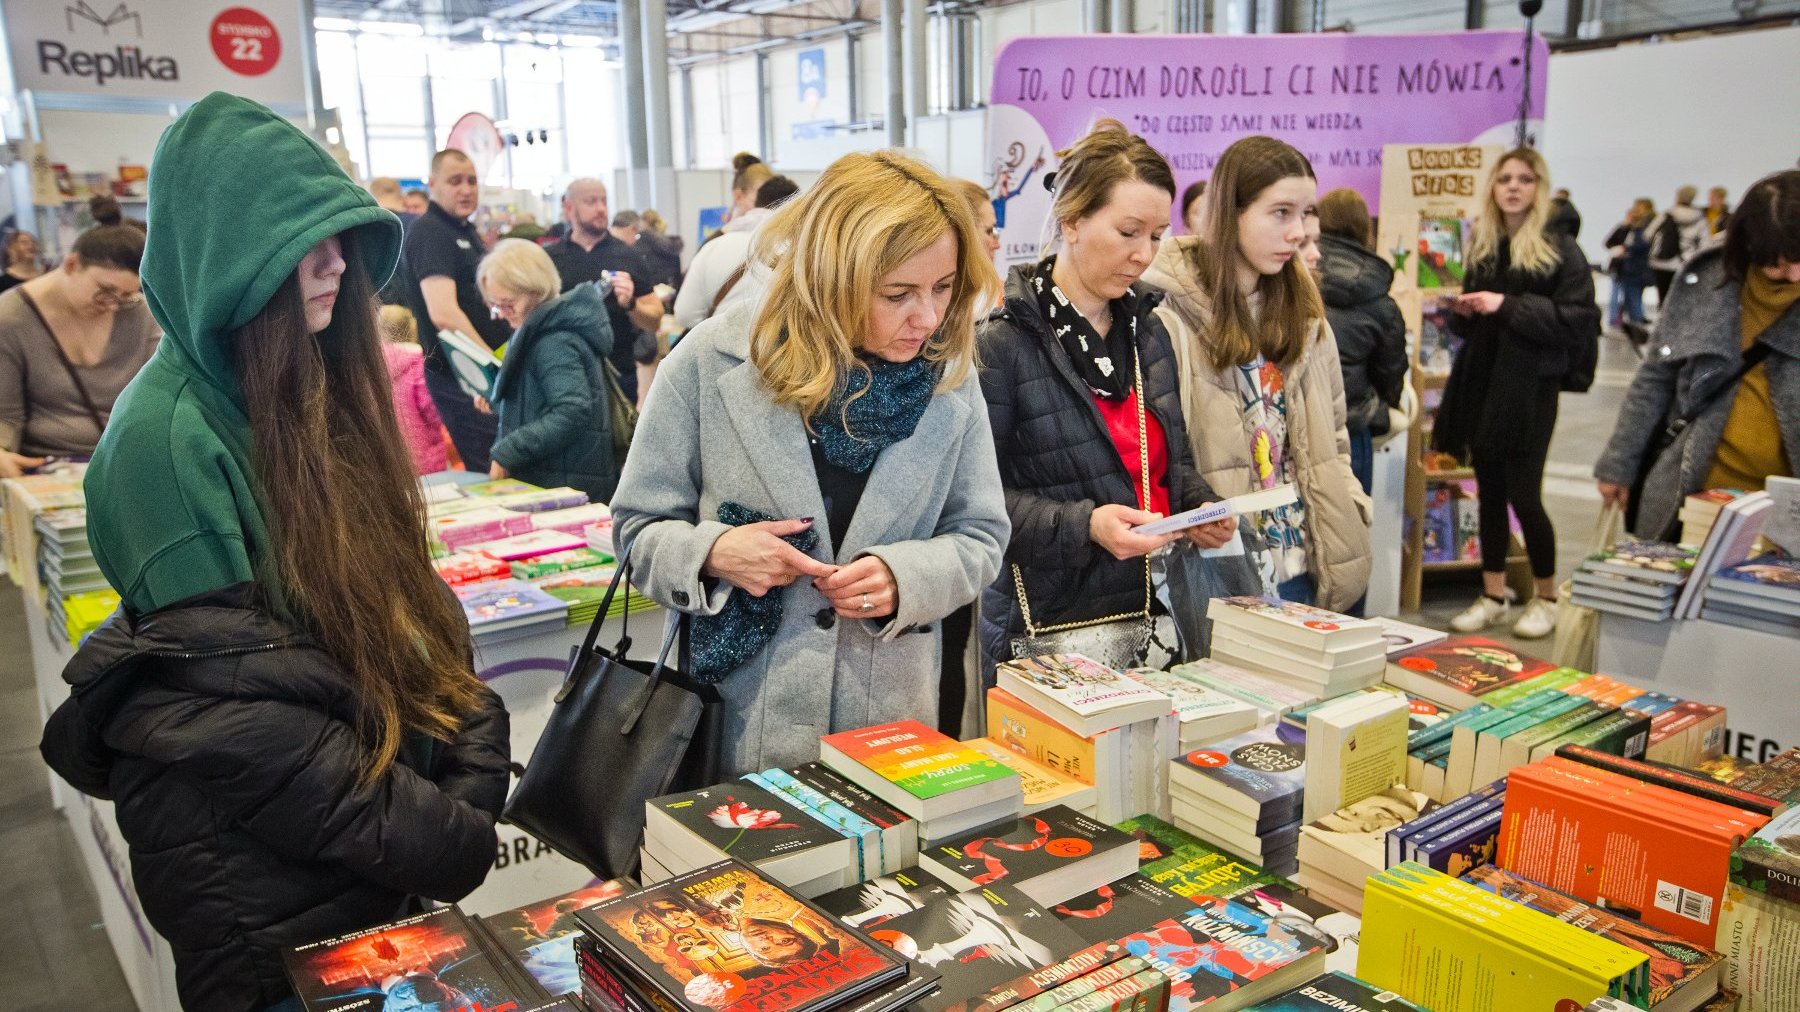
[502,547,724,879]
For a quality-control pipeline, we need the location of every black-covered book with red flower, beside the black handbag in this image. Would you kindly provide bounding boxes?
[644,780,851,882]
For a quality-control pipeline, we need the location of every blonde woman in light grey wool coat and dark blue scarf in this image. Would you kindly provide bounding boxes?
[612,151,1008,773]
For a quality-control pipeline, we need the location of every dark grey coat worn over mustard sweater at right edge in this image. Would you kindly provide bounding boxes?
[1593,248,1800,537]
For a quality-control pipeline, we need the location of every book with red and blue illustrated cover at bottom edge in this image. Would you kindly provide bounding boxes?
[1120,897,1330,1012]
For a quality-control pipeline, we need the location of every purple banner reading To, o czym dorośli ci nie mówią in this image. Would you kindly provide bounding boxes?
[983,31,1550,263]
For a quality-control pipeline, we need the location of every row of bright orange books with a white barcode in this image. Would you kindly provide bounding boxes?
[1496,758,1768,945]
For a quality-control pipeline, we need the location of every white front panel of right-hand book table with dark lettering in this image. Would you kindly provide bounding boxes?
[1595,612,1800,762]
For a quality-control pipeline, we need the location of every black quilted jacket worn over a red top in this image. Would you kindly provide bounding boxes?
[976,265,1215,661]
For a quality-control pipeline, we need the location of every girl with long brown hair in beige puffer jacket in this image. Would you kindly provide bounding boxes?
[1145,137,1370,610]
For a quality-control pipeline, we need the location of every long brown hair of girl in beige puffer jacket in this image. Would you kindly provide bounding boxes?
[1188,137,1325,371]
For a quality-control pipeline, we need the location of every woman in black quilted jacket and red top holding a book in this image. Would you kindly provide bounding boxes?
[977,121,1237,666]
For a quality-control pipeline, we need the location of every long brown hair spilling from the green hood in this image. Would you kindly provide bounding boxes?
[230,234,481,780]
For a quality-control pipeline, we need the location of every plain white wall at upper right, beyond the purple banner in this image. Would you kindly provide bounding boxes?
[1543,29,1800,263]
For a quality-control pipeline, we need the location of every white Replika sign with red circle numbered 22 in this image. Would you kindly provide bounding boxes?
[4,0,306,106]
